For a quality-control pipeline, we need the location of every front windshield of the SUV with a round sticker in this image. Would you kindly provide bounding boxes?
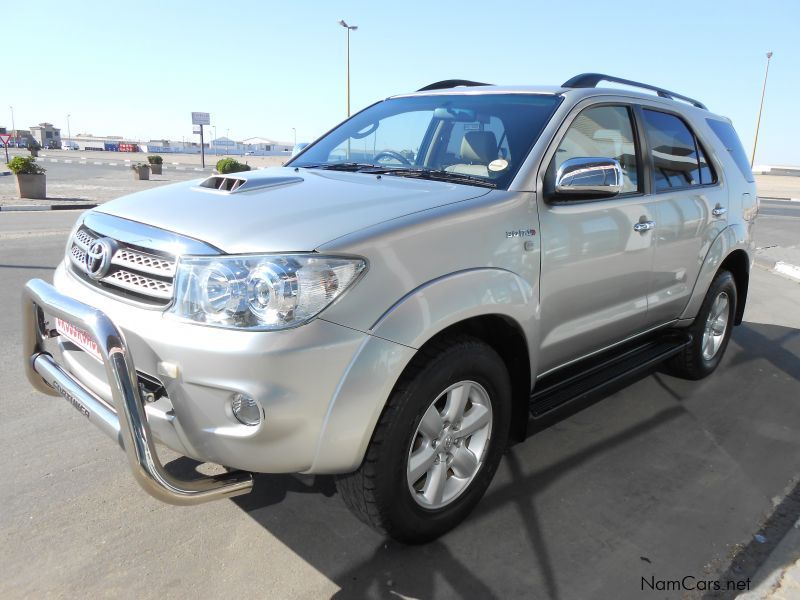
[287,94,561,188]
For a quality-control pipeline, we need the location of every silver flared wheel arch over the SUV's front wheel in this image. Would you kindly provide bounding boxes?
[308,268,538,473]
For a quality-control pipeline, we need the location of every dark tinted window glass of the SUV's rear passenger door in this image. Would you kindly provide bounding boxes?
[643,109,716,192]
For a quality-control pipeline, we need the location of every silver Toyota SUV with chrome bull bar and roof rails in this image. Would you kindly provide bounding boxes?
[23,74,757,542]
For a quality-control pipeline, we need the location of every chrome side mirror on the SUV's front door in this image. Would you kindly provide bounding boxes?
[555,157,622,197]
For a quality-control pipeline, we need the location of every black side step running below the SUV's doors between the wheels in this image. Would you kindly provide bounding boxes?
[530,330,692,419]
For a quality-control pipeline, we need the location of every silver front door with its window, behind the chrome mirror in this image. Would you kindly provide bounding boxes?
[538,102,655,373]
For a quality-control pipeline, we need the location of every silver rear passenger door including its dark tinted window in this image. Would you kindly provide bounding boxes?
[639,106,728,324]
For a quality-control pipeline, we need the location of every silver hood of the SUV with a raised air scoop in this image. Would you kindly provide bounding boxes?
[95,167,489,254]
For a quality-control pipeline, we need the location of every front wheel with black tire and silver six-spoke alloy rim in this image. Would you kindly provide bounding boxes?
[337,336,511,543]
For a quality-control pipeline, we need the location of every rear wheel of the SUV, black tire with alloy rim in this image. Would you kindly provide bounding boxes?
[669,271,737,379]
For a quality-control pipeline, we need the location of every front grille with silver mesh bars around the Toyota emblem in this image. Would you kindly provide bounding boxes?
[68,227,177,306]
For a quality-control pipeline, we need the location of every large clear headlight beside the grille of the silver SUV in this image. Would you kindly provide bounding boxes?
[168,254,366,331]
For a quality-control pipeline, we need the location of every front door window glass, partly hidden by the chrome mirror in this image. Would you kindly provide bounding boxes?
[553,106,639,194]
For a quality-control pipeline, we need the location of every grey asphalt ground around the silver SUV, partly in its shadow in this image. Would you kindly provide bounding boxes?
[0,207,800,600]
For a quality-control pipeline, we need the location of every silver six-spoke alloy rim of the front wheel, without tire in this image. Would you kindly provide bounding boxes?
[406,381,492,510]
